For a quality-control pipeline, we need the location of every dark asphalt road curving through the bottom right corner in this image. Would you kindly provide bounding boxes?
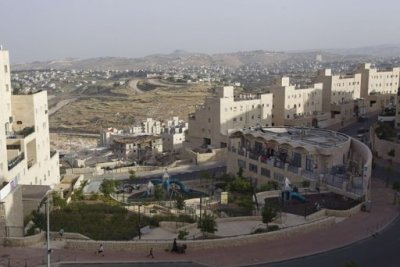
[260,219,400,267]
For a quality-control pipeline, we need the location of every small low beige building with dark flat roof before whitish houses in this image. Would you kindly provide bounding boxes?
[112,135,163,161]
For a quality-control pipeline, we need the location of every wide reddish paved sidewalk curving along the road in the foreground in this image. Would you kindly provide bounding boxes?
[0,179,399,266]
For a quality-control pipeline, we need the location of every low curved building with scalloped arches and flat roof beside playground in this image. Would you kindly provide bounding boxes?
[227,127,372,199]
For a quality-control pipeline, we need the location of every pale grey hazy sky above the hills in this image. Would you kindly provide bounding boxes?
[0,0,400,63]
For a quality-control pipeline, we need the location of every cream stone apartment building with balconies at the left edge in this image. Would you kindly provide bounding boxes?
[0,50,60,236]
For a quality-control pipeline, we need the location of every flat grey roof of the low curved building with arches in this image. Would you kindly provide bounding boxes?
[230,127,350,148]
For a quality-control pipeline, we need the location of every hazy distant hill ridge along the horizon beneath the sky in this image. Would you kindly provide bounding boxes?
[13,45,400,70]
